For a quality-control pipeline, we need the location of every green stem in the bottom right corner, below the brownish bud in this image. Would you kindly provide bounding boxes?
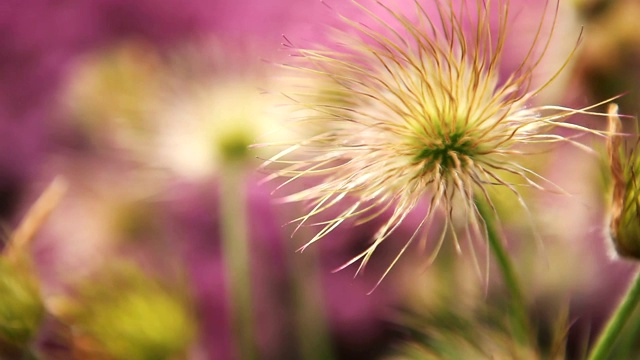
[589,273,640,360]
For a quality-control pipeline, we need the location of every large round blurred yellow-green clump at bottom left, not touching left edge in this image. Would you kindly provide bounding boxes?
[68,267,196,360]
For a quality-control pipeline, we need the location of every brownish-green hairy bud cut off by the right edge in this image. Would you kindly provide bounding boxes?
[607,104,640,260]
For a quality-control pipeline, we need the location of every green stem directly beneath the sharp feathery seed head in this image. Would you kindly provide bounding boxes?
[476,200,531,345]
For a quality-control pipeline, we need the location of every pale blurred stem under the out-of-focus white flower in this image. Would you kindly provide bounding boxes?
[220,161,257,360]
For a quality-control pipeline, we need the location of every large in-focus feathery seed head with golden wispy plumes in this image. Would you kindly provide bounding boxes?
[263,0,603,286]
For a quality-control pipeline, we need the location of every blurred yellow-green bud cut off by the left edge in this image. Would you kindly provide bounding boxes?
[0,256,44,351]
